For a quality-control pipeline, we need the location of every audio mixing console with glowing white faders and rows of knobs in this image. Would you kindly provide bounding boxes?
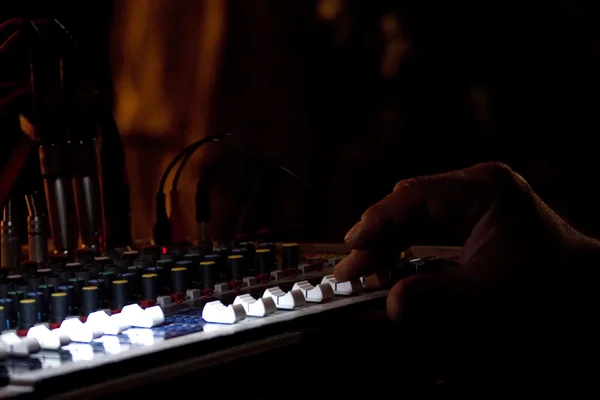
[0,242,460,391]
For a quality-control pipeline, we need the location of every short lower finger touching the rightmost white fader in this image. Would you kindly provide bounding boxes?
[333,250,398,282]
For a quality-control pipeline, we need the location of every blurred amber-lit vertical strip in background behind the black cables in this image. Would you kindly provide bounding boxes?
[112,0,226,239]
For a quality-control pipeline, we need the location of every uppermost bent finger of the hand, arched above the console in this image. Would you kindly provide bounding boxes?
[346,163,514,249]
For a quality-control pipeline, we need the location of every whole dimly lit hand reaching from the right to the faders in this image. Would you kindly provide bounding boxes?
[334,163,600,384]
